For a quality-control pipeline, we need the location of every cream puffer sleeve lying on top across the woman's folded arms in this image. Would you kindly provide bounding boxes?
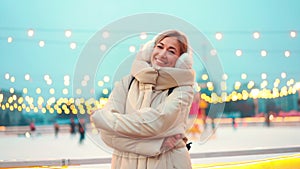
[92,83,193,139]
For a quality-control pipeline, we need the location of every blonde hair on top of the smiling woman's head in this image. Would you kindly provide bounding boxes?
[154,30,188,55]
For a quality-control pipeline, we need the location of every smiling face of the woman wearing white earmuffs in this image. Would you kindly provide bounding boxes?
[151,37,180,67]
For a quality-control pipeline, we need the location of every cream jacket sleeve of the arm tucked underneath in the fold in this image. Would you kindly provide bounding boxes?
[92,78,163,156]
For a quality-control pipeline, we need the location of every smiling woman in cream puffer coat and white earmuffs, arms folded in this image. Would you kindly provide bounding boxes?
[91,30,195,169]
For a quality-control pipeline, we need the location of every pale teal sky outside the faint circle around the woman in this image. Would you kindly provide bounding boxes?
[0,0,300,97]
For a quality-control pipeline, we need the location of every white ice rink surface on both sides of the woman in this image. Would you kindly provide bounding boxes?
[0,126,300,169]
